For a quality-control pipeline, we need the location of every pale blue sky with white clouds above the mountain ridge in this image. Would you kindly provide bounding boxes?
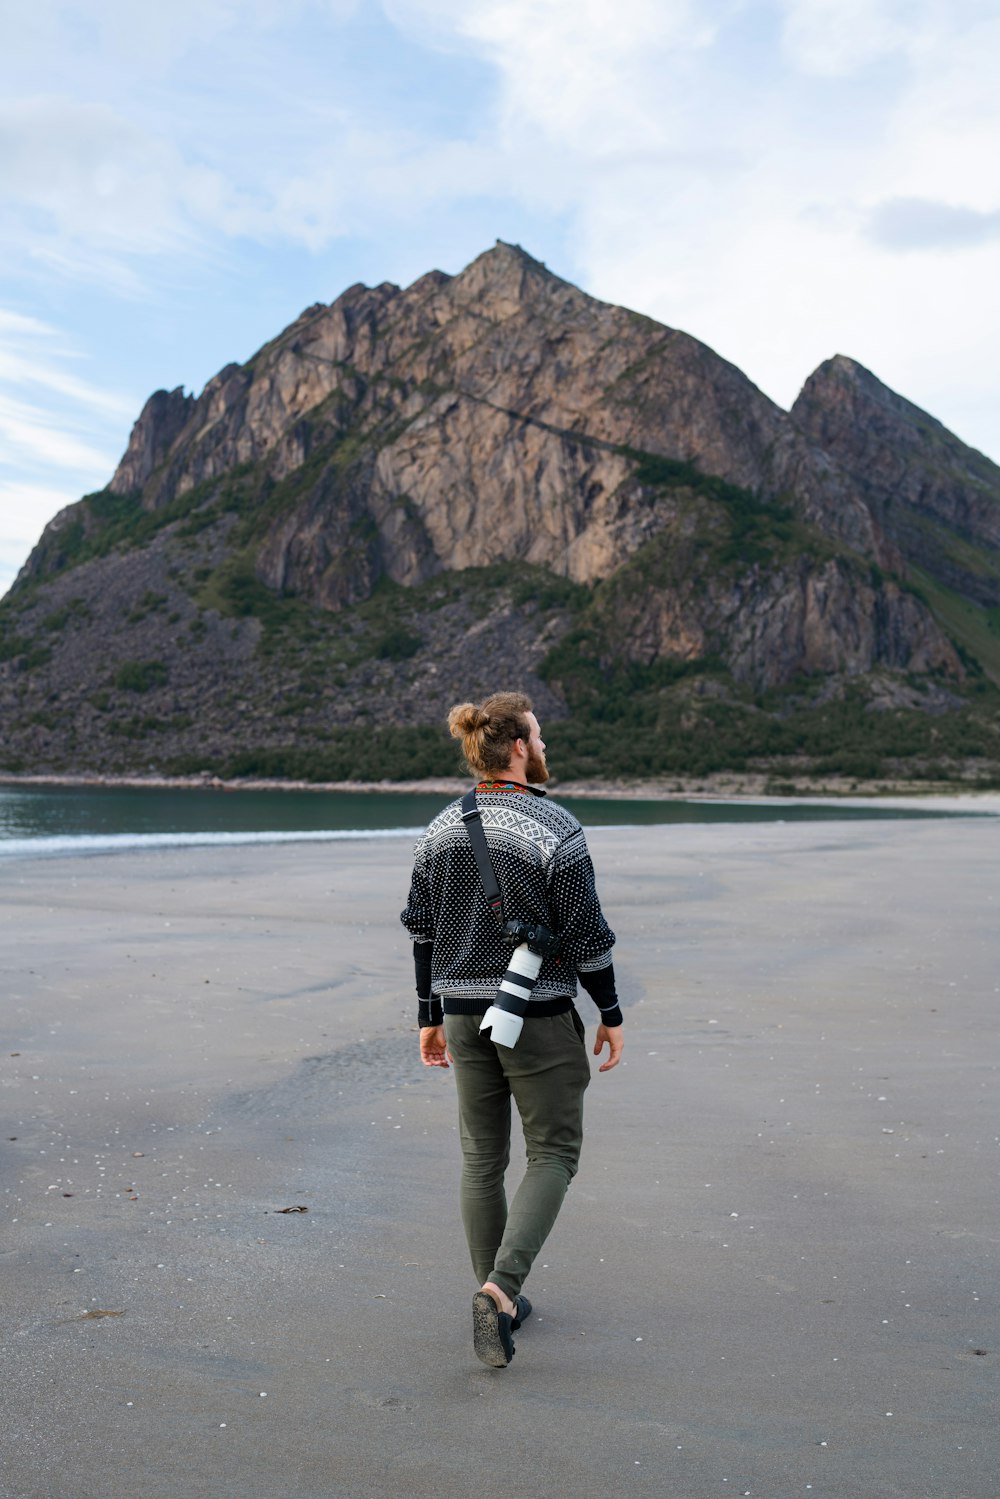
[0,0,1000,594]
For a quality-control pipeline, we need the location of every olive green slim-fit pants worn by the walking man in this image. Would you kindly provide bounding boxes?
[444,1010,591,1297]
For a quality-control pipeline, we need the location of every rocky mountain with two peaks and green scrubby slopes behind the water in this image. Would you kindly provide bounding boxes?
[0,243,1000,775]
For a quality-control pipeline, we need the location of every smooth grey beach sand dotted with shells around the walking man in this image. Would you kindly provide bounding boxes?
[0,820,1000,1499]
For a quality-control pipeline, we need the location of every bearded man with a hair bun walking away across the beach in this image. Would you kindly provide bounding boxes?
[402,693,622,1369]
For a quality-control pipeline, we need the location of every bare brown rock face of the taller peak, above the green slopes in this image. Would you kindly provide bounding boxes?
[111,244,892,607]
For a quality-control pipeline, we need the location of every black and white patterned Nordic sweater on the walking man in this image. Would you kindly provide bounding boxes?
[400,782,621,1025]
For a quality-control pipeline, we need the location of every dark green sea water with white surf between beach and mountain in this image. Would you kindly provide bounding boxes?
[0,785,977,859]
